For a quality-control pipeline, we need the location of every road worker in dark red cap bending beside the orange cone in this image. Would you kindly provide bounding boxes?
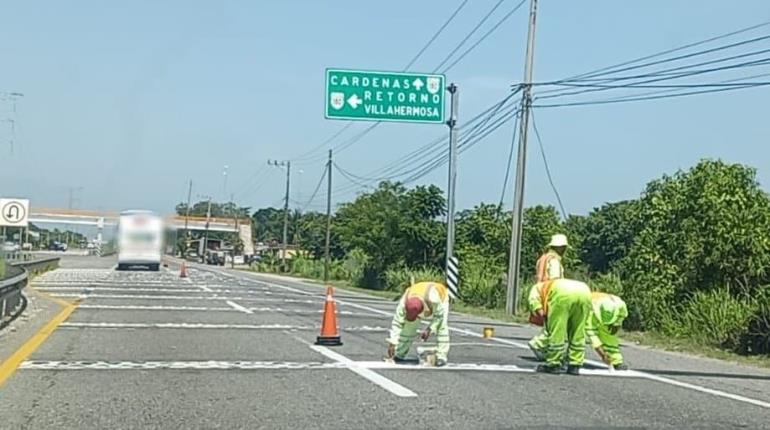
[388,282,449,366]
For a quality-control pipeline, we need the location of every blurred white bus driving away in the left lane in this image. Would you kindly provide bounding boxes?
[117,210,163,271]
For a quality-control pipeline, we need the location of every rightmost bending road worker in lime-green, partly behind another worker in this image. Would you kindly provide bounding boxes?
[586,292,628,370]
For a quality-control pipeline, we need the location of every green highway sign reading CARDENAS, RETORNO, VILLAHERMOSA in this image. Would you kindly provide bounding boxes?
[325,69,445,123]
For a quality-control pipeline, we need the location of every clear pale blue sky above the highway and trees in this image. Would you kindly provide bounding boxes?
[0,0,770,213]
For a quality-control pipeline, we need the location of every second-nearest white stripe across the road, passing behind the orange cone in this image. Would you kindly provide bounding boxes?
[59,322,389,333]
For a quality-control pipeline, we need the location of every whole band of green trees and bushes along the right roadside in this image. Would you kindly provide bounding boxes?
[195,160,770,355]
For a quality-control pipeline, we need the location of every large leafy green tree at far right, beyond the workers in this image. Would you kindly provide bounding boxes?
[618,160,770,328]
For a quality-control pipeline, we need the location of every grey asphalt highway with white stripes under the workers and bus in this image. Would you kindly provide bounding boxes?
[0,256,770,429]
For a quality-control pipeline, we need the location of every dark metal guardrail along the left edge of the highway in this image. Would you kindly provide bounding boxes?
[0,257,59,329]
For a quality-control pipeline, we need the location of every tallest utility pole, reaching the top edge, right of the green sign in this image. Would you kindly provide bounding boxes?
[505,0,537,315]
